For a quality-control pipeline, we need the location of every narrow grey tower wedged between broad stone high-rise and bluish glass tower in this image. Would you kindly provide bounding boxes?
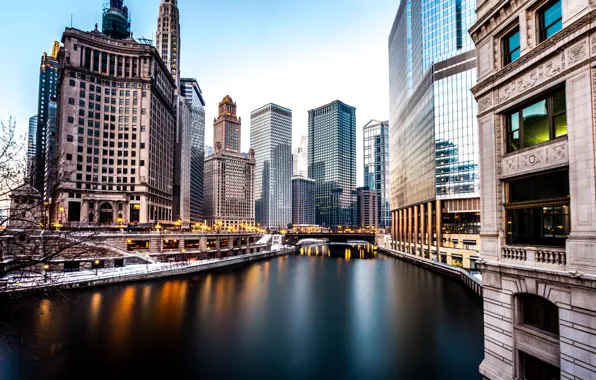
[172,97,192,226]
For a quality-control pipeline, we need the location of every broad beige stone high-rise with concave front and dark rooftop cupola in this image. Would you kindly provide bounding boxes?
[53,1,176,226]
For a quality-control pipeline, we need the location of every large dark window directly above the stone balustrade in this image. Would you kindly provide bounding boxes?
[505,170,571,247]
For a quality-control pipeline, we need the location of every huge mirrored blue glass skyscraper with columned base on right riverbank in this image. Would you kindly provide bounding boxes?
[389,0,480,269]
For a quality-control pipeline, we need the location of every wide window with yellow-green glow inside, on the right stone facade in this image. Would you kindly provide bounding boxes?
[507,89,567,152]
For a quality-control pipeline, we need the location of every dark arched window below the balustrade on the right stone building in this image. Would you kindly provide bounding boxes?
[518,294,559,335]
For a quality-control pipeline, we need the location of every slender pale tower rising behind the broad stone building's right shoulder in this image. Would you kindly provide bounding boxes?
[155,0,180,86]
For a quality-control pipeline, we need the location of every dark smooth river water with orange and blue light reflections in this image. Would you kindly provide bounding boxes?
[0,248,483,380]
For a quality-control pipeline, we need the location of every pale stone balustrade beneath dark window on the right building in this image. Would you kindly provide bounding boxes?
[501,246,567,270]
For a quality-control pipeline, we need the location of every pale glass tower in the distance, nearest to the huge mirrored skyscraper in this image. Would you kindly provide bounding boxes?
[364,120,391,228]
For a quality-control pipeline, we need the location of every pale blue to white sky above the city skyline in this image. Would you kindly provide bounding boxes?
[0,0,399,186]
